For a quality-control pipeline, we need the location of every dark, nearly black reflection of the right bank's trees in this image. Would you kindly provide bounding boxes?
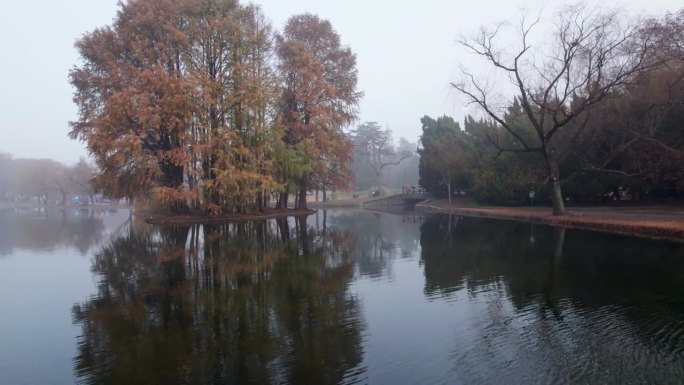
[421,215,684,306]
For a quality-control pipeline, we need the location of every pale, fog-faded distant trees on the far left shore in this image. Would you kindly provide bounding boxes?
[0,153,96,205]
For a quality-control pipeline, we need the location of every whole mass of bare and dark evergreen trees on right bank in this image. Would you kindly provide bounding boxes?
[419,6,684,215]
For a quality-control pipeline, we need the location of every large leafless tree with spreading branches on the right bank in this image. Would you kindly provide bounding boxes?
[451,5,653,215]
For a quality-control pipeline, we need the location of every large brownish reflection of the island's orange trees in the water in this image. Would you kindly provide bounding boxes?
[73,218,364,384]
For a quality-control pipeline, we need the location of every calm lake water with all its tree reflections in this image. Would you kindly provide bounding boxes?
[0,209,684,385]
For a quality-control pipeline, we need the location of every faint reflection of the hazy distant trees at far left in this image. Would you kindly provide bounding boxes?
[0,207,105,255]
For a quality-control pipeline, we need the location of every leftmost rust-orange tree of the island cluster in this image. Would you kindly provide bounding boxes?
[70,0,193,212]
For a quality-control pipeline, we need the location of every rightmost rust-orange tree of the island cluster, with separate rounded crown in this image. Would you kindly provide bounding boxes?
[276,14,362,208]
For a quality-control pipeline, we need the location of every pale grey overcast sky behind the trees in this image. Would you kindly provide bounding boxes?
[0,0,684,164]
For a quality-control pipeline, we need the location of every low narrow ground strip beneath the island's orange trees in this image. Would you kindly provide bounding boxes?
[142,208,316,226]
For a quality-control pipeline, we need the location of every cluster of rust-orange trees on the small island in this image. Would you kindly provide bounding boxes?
[70,0,362,214]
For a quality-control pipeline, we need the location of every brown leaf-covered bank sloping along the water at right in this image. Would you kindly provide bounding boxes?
[417,199,684,242]
